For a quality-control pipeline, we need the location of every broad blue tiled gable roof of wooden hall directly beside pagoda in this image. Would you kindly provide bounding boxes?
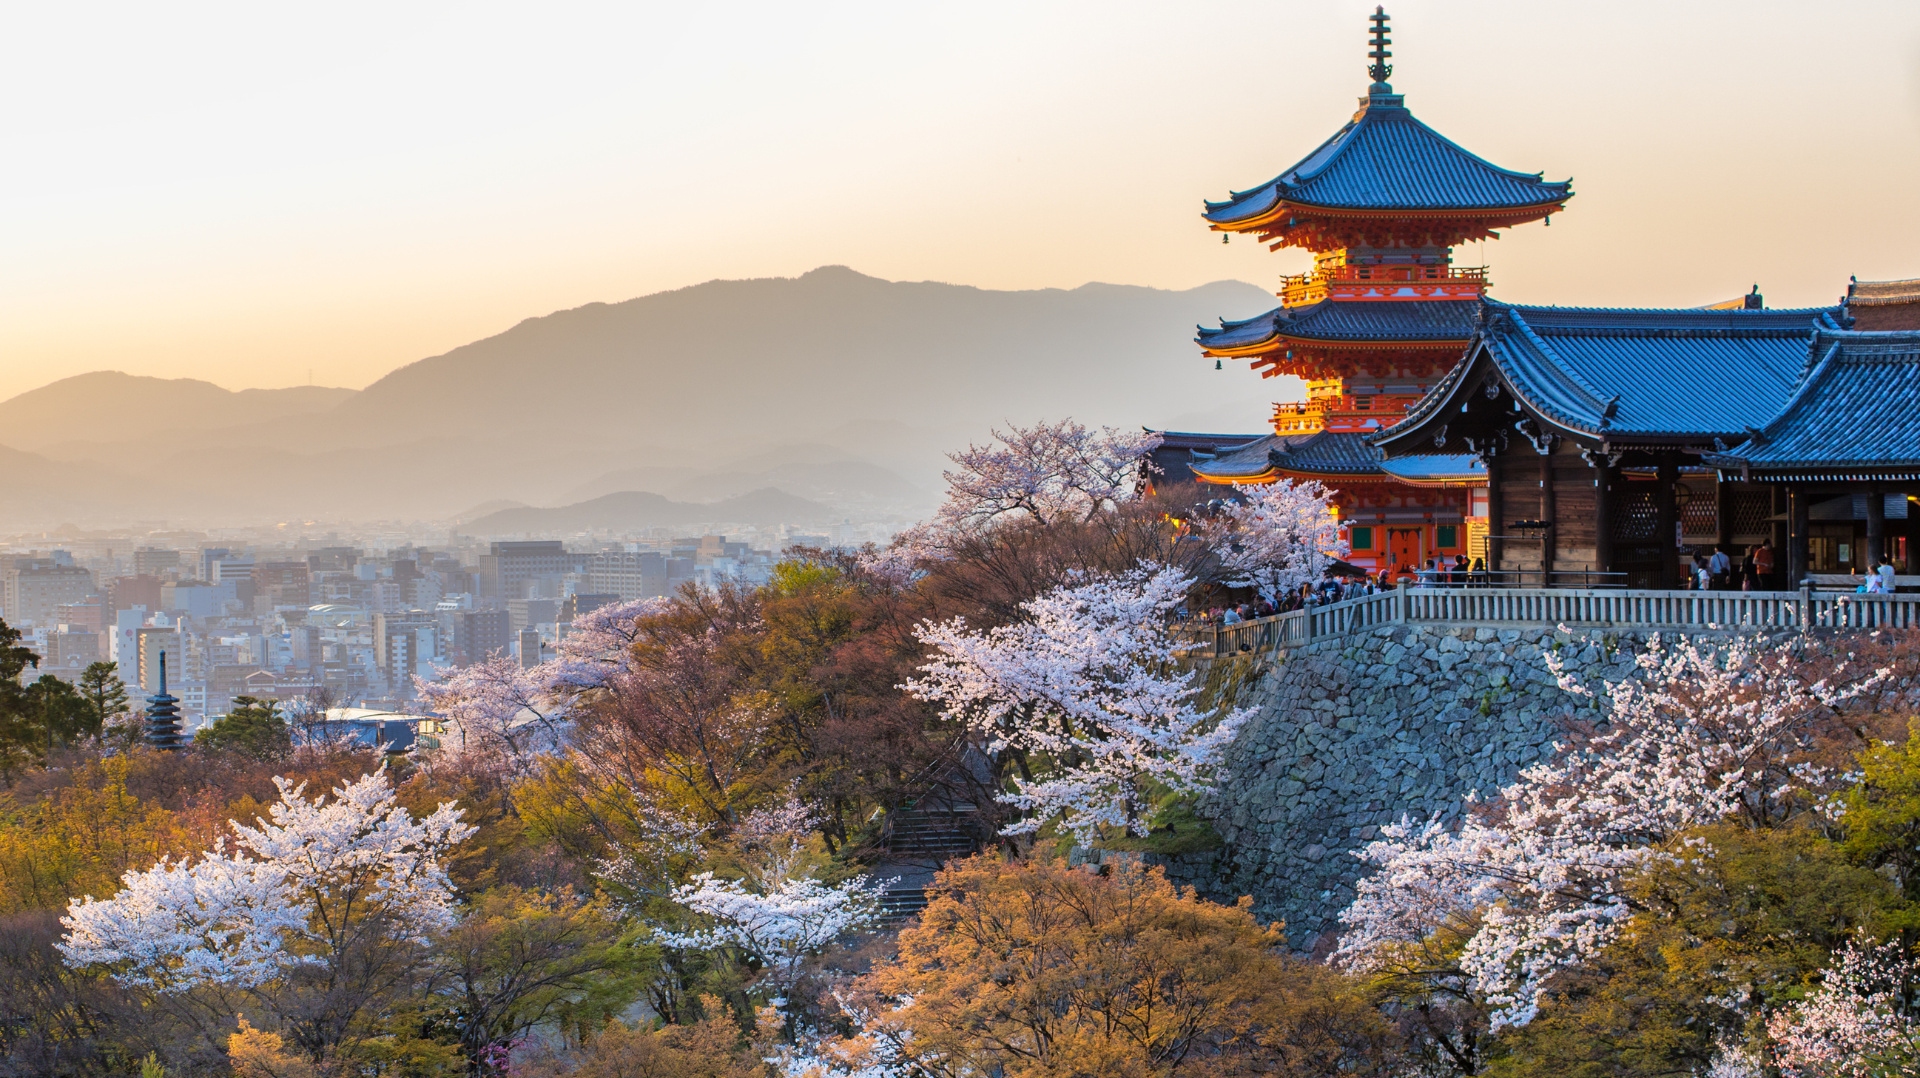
[1375,300,1839,446]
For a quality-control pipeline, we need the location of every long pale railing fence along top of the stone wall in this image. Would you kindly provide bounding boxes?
[1177,584,1920,655]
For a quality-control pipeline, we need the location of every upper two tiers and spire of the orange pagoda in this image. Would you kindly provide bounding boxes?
[1198,8,1572,434]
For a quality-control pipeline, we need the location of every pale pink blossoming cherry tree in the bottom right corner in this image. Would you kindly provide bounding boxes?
[1766,940,1920,1078]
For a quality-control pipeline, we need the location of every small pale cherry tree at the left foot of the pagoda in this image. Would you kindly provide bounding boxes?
[1192,478,1350,601]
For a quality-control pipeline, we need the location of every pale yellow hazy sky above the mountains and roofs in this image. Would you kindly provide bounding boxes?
[0,0,1920,398]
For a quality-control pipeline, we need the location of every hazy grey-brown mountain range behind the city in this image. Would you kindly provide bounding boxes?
[0,267,1273,534]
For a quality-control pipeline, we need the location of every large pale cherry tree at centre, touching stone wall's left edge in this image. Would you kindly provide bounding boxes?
[902,563,1250,842]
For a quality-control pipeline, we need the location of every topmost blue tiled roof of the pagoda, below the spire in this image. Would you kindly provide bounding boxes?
[1206,94,1572,225]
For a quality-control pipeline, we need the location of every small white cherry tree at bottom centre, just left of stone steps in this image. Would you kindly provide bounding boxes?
[660,792,885,988]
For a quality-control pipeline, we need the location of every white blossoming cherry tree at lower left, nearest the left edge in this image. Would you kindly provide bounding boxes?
[60,769,474,990]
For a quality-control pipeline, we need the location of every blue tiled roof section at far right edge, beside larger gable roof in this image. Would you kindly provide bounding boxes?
[1707,329,1920,475]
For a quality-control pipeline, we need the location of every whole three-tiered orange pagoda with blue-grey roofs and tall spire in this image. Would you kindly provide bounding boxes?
[1169,8,1572,573]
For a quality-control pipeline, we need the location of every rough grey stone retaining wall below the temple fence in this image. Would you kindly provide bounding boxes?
[1167,625,1645,951]
